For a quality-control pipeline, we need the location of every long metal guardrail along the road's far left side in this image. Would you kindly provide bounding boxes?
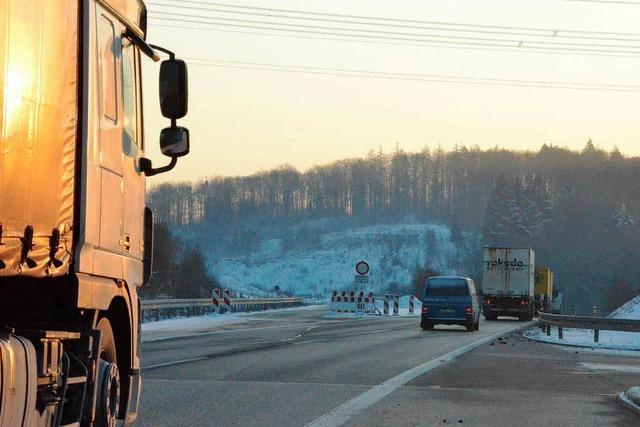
[140,298,305,321]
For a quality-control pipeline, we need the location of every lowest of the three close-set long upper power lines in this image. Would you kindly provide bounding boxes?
[146,17,640,56]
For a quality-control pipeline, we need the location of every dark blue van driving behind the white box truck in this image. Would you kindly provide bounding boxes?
[420,276,480,332]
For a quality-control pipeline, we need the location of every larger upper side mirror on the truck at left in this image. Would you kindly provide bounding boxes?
[158,59,189,120]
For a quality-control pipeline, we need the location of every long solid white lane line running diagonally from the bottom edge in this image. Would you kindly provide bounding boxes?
[306,322,534,427]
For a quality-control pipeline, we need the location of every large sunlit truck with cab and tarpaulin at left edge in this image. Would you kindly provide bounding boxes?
[0,0,189,427]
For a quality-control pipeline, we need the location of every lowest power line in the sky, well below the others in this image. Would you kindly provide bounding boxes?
[176,58,640,93]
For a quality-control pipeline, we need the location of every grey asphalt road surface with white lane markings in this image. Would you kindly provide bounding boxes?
[137,309,640,427]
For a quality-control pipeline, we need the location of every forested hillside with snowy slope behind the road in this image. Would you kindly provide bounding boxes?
[149,141,640,314]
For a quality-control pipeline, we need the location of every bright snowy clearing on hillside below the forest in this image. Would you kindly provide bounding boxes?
[209,224,459,295]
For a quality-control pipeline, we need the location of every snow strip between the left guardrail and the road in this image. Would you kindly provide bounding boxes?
[142,305,325,342]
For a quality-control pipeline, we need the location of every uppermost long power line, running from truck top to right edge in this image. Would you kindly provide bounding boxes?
[149,0,640,37]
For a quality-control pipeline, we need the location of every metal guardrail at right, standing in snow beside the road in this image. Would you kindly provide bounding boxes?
[538,313,640,342]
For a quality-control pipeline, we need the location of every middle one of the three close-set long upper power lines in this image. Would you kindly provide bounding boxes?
[148,12,640,53]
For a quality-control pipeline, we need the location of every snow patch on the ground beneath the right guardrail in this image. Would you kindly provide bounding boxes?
[524,327,640,351]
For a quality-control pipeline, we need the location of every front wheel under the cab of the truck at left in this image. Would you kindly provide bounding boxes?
[93,317,120,427]
